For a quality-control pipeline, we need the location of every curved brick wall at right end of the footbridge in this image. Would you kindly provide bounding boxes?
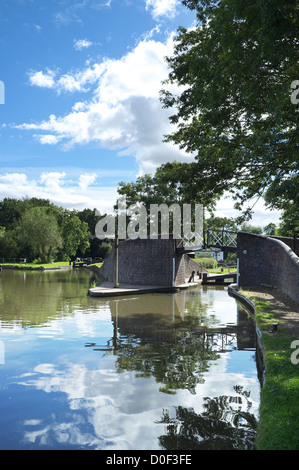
[238,232,299,302]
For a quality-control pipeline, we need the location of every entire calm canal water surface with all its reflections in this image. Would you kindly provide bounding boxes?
[0,269,260,450]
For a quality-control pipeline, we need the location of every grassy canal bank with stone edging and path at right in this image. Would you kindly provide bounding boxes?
[229,285,299,450]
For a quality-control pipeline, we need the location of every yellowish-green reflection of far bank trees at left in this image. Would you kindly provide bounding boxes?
[0,269,92,328]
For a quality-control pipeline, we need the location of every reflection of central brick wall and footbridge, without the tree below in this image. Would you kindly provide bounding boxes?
[85,291,256,358]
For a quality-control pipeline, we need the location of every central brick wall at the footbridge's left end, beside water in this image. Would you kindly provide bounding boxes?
[98,238,206,286]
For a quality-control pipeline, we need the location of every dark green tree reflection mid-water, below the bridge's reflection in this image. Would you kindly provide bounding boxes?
[116,332,219,394]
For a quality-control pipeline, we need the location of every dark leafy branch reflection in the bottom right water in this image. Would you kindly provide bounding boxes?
[159,386,257,450]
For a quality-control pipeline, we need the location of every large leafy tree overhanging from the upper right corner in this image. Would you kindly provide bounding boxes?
[161,0,299,219]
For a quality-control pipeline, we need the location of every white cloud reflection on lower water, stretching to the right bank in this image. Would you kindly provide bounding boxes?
[18,354,258,450]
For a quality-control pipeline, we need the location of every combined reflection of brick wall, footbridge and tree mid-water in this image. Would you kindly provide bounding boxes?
[86,292,255,394]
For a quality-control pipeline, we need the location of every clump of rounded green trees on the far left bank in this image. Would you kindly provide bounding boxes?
[0,198,99,262]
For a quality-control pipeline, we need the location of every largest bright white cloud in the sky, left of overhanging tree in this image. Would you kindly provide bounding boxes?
[17,36,192,173]
